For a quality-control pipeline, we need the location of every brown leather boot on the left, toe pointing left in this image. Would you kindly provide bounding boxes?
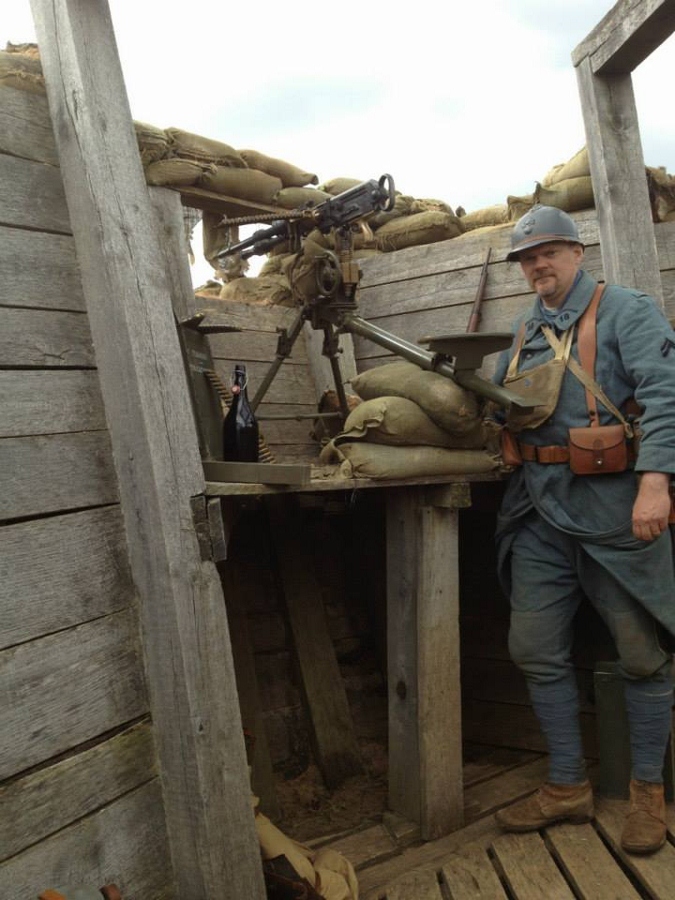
[495,781,595,831]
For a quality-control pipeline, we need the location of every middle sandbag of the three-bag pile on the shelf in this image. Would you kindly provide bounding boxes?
[335,397,487,450]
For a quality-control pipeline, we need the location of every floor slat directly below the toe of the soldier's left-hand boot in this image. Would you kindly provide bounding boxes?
[492,832,574,900]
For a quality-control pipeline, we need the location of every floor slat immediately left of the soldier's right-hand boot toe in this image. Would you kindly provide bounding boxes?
[545,823,640,900]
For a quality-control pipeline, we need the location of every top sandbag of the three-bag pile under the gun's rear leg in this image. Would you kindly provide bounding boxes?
[351,360,481,435]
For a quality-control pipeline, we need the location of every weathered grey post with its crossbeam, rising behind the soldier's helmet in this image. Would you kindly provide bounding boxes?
[572,0,675,306]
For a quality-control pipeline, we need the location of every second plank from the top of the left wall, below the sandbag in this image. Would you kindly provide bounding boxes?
[0,154,71,234]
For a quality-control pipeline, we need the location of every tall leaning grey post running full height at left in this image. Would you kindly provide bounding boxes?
[31,0,265,900]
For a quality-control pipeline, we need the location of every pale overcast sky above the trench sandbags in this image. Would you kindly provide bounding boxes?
[0,0,675,282]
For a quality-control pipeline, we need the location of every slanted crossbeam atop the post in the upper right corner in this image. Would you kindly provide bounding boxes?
[572,0,675,76]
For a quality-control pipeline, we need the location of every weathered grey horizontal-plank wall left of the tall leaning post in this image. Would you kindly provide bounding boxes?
[0,87,173,900]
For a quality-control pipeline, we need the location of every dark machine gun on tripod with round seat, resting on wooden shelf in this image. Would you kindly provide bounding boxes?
[218,175,533,421]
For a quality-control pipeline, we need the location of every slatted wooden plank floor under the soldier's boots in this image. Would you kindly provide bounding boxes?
[330,752,675,900]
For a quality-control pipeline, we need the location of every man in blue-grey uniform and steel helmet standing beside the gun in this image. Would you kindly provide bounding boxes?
[495,205,675,853]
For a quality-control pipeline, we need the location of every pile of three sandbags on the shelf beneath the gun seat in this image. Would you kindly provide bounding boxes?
[320,361,500,479]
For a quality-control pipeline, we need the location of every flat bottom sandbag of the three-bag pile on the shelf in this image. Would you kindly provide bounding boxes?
[319,440,501,479]
